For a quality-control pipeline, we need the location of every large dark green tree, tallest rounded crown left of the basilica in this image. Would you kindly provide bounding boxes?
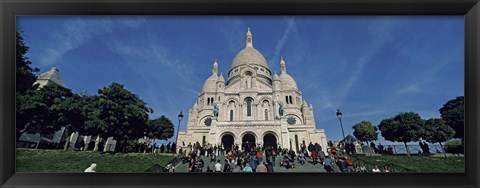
[97,82,152,152]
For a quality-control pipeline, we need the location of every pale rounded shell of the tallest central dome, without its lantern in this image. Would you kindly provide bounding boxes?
[232,46,270,69]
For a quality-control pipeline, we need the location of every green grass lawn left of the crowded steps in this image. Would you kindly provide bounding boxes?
[16,149,175,173]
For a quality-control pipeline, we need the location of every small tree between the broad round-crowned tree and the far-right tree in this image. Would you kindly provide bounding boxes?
[424,118,455,157]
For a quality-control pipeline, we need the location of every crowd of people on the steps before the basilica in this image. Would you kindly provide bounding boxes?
[174,142,389,172]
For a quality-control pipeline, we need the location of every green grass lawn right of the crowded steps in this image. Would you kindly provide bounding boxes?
[359,155,465,173]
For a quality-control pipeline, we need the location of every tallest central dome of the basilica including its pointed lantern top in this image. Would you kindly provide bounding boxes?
[231,28,270,69]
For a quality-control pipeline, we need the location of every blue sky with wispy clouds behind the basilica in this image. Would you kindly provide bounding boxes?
[17,16,464,143]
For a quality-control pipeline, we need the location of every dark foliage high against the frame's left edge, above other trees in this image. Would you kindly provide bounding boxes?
[15,28,39,94]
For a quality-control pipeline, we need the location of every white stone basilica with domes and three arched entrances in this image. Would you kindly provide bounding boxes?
[177,29,327,152]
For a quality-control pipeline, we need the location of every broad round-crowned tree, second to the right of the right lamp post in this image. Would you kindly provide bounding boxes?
[378,112,424,156]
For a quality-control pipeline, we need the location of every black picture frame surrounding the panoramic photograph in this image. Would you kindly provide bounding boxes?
[0,0,480,188]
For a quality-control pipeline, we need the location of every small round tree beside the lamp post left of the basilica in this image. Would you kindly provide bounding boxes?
[145,115,174,140]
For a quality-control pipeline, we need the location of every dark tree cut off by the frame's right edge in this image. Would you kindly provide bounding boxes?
[439,96,465,138]
